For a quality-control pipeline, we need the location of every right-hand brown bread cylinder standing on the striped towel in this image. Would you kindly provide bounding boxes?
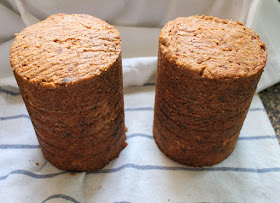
[153,16,267,167]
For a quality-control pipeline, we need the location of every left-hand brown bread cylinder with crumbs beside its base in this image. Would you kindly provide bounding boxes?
[10,14,125,171]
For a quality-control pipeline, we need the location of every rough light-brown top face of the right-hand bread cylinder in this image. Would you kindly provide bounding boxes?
[159,16,267,79]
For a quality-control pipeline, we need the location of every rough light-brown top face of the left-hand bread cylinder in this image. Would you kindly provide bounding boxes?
[10,14,121,87]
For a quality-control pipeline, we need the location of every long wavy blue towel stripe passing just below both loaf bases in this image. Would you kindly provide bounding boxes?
[0,163,280,181]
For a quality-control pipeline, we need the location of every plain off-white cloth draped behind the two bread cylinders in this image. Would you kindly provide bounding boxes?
[0,0,280,92]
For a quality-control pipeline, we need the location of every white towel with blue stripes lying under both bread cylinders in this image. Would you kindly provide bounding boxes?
[0,80,280,203]
